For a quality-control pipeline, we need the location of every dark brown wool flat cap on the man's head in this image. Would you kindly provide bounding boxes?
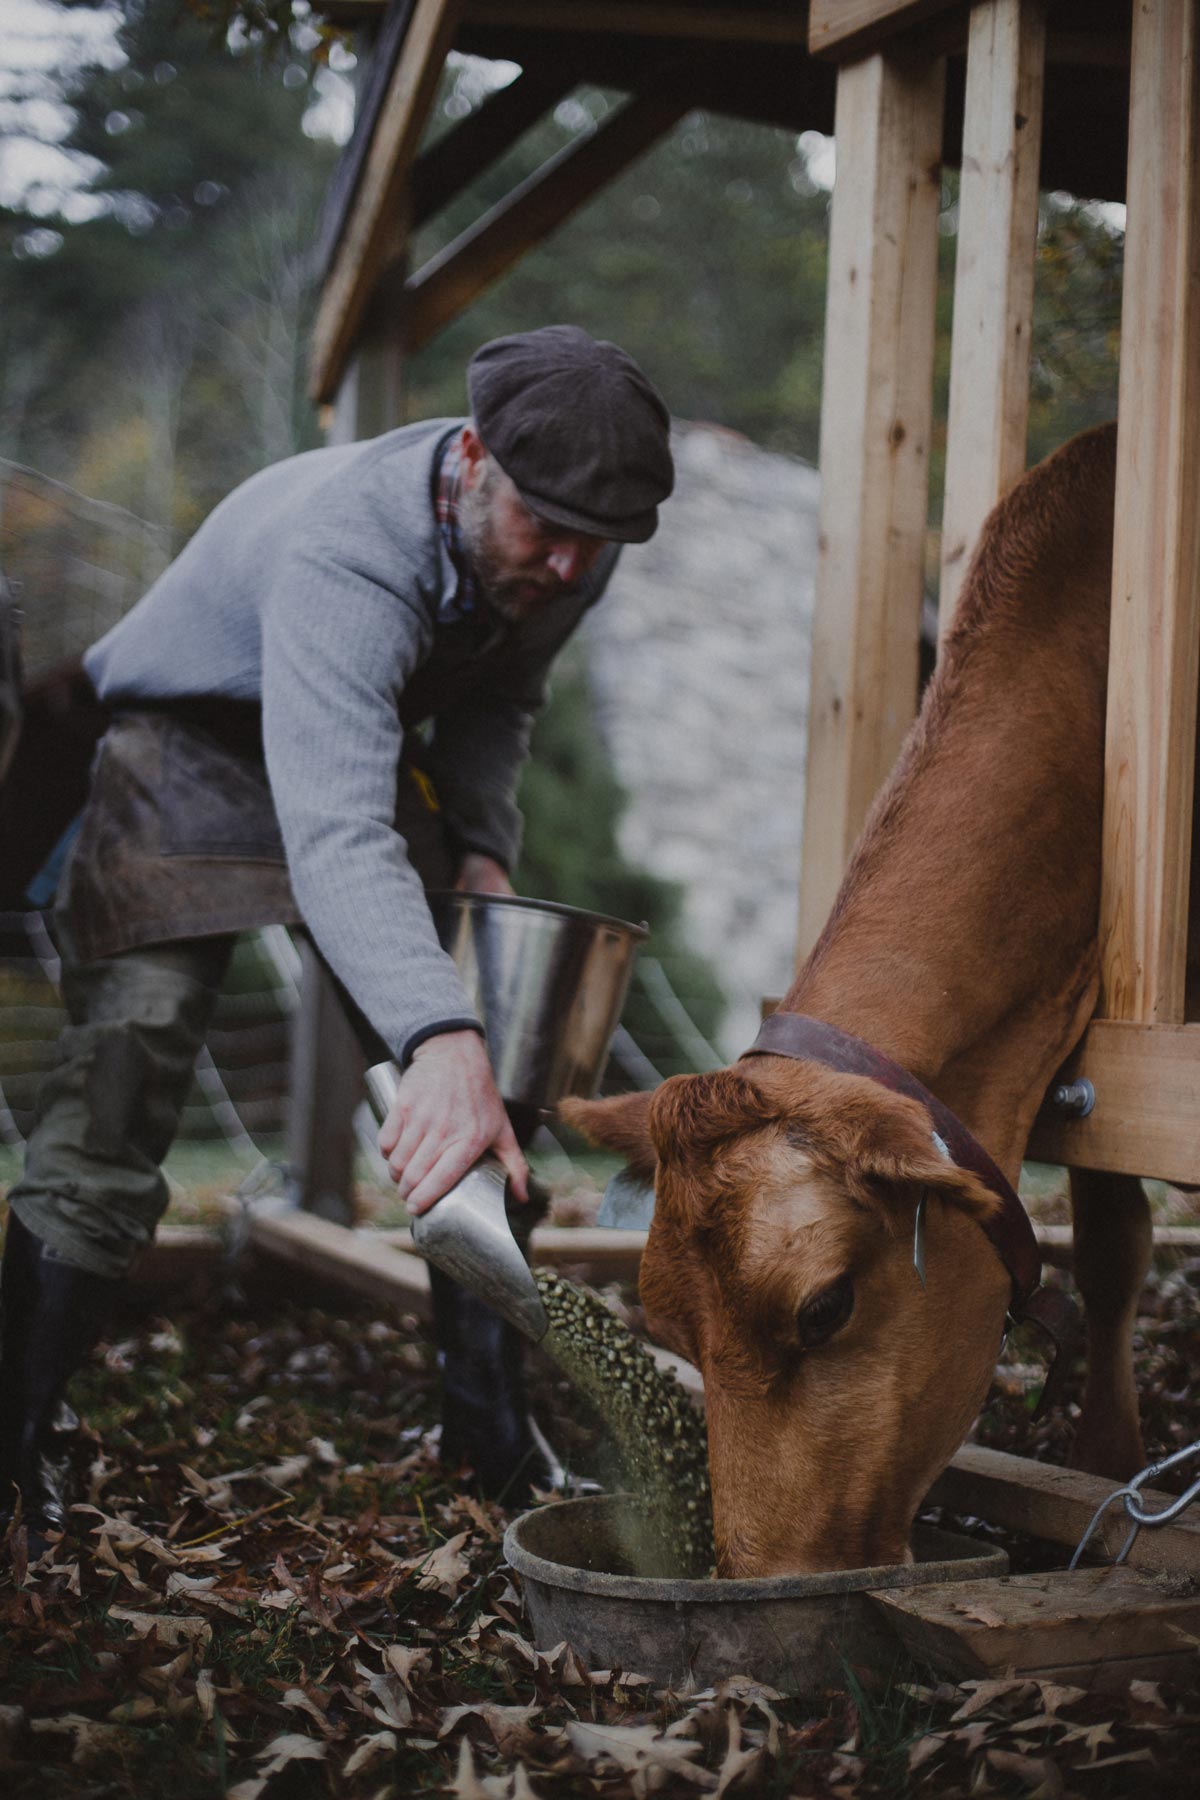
[466,326,675,544]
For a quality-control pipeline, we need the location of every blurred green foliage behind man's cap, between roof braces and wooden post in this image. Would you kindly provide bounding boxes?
[412,94,828,459]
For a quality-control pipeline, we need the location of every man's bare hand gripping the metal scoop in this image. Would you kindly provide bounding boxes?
[380,1031,529,1213]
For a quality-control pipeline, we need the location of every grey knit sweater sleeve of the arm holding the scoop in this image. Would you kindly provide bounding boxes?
[263,518,479,1064]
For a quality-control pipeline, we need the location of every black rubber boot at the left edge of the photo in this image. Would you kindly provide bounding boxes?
[0,1211,121,1553]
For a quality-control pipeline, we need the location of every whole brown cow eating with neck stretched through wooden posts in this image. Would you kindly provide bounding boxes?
[563,427,1150,1575]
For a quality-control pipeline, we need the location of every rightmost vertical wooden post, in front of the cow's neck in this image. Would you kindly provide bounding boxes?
[1099,0,1200,1024]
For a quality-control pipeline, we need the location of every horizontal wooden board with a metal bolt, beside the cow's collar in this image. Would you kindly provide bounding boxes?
[1025,1019,1200,1184]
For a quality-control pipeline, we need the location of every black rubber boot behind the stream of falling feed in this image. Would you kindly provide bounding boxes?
[430,1181,582,1507]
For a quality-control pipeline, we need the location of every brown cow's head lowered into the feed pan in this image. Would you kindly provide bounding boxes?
[561,1057,1011,1577]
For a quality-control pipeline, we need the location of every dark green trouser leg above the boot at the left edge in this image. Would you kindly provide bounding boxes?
[9,938,234,1276]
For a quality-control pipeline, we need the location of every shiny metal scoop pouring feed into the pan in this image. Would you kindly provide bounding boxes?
[367,1062,551,1343]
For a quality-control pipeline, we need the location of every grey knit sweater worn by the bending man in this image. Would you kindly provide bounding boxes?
[85,419,615,1062]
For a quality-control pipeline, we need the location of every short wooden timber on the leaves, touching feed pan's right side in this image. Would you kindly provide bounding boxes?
[867,1568,1200,1681]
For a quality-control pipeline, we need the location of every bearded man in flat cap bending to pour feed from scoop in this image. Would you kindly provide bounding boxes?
[0,326,673,1532]
